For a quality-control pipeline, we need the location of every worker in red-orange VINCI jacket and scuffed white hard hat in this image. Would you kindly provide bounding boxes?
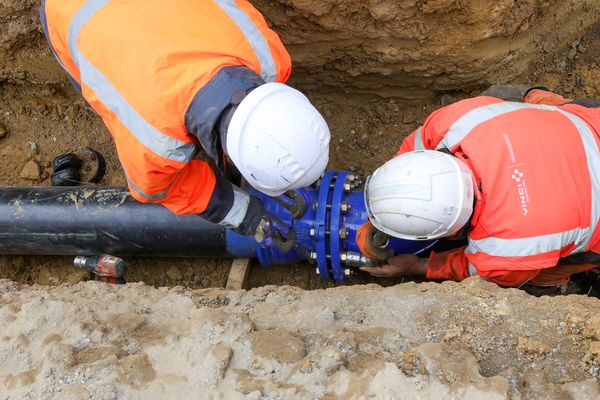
[364,88,600,287]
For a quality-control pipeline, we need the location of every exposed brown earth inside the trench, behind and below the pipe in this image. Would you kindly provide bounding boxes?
[0,0,600,289]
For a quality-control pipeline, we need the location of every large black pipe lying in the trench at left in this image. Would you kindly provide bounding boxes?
[0,187,254,257]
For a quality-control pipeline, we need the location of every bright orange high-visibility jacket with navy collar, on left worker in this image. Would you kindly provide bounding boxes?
[41,0,291,214]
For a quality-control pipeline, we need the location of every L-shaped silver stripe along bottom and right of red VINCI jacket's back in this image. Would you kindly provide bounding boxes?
[466,107,600,257]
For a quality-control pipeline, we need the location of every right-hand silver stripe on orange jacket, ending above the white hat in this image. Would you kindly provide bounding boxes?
[215,0,277,82]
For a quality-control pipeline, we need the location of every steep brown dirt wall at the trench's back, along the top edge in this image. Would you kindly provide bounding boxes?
[0,0,600,99]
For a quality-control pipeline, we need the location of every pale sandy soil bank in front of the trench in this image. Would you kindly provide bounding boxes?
[0,279,600,399]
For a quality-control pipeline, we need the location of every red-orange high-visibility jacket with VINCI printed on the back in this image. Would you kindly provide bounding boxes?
[399,97,600,286]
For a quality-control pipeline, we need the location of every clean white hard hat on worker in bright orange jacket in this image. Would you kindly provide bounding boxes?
[227,82,330,196]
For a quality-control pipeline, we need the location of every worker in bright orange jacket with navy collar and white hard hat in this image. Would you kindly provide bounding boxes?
[41,0,330,247]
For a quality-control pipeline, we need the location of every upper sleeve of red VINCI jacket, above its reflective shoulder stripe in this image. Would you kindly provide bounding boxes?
[396,96,504,155]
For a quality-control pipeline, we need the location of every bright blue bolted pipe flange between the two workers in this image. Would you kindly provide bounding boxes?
[244,171,435,282]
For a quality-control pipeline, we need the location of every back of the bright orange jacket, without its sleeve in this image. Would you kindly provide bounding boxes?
[41,0,290,139]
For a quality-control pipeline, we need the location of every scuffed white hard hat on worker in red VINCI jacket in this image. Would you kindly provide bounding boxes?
[365,150,476,240]
